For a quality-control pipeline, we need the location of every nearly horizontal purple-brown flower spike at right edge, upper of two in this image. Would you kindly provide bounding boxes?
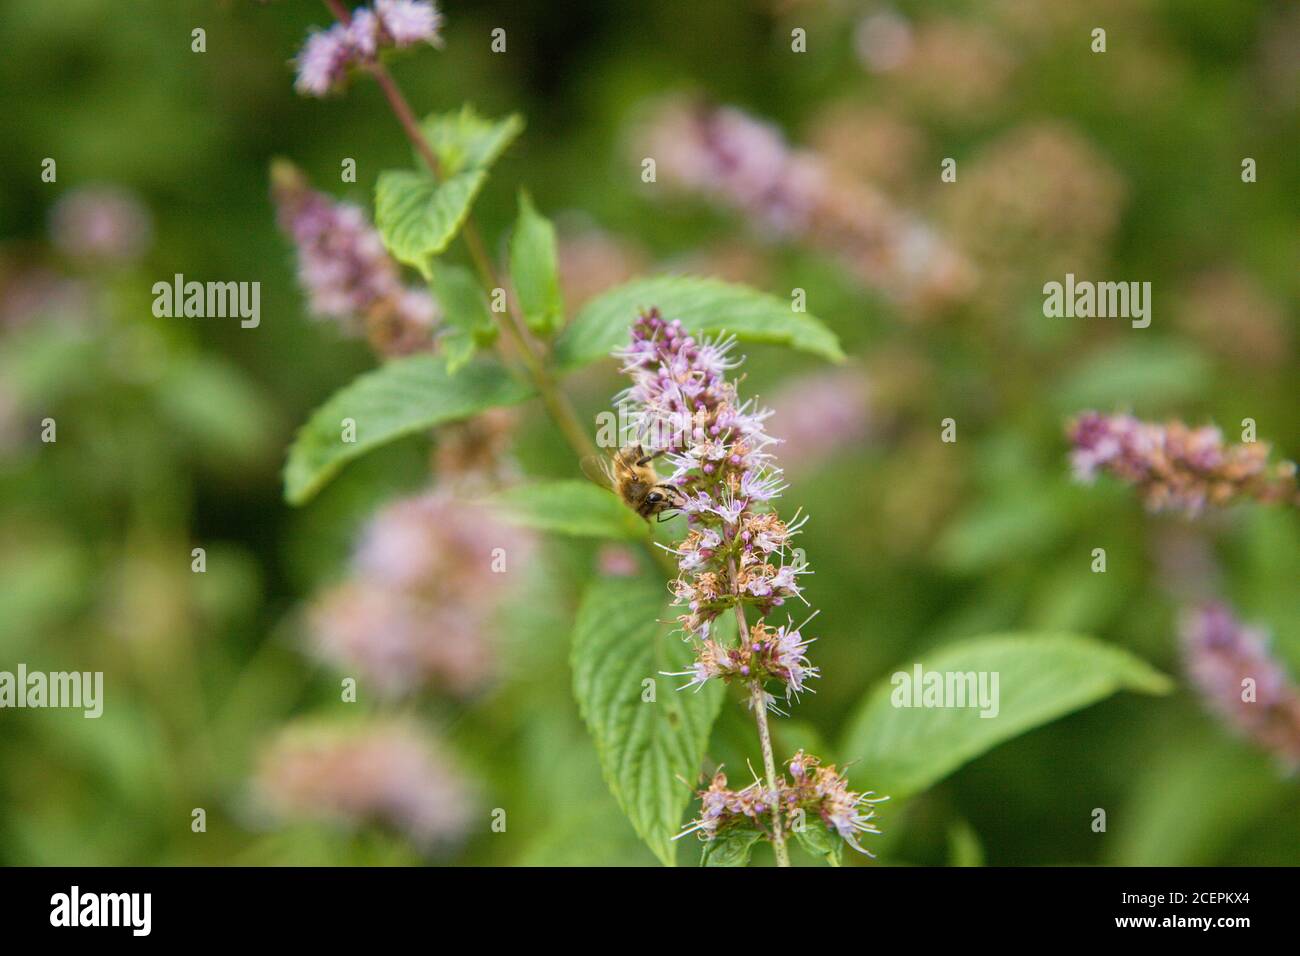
[1067,411,1300,518]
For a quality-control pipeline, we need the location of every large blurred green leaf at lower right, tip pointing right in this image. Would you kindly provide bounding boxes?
[840,635,1170,797]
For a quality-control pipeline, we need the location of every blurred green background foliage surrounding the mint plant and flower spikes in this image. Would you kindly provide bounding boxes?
[0,0,1300,865]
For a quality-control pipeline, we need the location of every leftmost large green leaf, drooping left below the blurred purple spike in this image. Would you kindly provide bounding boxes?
[285,352,532,505]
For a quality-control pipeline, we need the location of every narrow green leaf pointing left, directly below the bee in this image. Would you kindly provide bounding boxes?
[491,481,647,541]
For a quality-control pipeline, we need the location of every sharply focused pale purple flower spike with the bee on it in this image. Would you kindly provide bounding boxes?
[615,310,818,706]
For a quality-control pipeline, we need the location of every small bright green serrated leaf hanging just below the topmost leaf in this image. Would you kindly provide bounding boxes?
[374,169,488,278]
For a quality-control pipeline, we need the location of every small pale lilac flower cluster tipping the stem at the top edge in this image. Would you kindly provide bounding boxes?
[294,0,442,96]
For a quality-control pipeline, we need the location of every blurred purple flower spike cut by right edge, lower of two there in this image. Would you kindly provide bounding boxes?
[1180,604,1300,770]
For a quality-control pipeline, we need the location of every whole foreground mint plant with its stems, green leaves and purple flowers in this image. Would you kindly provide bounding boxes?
[273,0,1167,866]
